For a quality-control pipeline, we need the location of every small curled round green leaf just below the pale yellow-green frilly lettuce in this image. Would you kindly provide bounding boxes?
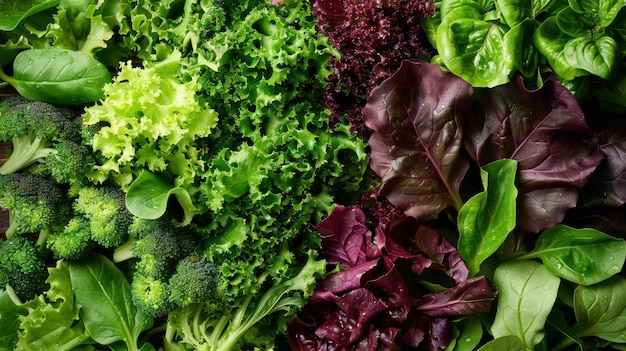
[126,170,198,225]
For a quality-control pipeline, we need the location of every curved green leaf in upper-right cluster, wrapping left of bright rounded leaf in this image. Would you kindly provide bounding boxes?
[533,16,589,80]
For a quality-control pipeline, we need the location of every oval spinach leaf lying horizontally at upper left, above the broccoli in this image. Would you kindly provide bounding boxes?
[0,48,111,105]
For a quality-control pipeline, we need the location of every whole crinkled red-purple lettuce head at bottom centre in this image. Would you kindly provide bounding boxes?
[288,205,495,351]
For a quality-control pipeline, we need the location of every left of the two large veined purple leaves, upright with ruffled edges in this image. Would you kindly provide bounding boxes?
[362,61,473,221]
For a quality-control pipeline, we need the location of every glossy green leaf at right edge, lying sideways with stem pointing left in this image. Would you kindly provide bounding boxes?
[524,225,626,285]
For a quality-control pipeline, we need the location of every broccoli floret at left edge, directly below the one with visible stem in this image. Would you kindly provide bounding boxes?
[0,173,71,240]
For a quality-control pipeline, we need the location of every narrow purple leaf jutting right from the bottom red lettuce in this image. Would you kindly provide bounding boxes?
[415,277,495,317]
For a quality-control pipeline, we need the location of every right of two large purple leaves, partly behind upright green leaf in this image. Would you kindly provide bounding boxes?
[465,76,603,233]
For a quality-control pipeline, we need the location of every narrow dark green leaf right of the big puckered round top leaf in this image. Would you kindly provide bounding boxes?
[504,18,539,77]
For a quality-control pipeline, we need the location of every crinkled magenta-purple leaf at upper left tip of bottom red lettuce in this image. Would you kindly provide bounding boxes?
[313,205,371,269]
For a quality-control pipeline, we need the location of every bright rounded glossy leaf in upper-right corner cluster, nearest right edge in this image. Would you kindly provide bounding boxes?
[563,36,621,79]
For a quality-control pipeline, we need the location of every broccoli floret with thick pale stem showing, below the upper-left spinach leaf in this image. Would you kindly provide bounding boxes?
[0,101,82,174]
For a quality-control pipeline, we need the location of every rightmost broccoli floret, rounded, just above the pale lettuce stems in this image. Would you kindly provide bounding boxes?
[169,255,222,307]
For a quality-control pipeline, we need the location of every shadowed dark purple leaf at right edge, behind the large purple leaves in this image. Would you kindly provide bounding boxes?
[579,127,626,208]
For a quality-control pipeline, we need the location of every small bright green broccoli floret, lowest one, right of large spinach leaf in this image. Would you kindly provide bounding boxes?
[130,272,177,318]
